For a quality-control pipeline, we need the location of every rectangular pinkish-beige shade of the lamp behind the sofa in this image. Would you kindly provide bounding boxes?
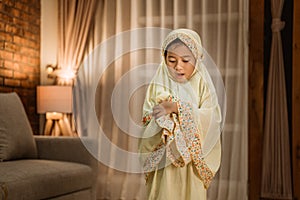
[37,85,72,113]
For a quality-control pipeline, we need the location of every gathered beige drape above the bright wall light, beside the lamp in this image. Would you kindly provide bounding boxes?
[56,0,97,85]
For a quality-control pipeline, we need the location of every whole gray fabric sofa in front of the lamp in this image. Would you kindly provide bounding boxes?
[0,93,98,200]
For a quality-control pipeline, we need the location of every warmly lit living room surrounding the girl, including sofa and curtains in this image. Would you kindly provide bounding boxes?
[0,0,300,200]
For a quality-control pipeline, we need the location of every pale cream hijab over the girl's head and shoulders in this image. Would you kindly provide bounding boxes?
[143,29,222,157]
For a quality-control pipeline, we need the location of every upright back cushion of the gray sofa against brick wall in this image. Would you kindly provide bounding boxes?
[0,93,37,161]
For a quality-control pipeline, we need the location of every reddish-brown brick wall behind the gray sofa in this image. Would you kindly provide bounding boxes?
[0,0,41,134]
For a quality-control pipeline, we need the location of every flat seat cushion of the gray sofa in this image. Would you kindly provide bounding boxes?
[0,159,93,200]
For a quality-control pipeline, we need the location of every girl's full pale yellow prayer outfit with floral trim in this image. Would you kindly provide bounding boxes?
[139,29,221,200]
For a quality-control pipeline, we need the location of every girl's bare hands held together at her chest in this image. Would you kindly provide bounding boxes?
[152,101,177,119]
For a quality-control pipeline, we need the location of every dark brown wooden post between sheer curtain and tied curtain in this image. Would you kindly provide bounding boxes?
[248,0,264,200]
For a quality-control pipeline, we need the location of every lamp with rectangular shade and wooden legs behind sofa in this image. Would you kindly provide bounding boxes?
[37,85,72,136]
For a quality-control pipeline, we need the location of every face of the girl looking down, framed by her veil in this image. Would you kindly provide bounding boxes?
[166,43,196,83]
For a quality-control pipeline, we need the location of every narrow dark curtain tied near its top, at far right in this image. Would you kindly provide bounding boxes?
[261,0,292,199]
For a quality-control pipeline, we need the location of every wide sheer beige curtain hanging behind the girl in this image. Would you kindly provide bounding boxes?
[74,0,248,200]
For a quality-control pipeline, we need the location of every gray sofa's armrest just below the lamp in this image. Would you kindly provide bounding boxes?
[34,136,98,169]
